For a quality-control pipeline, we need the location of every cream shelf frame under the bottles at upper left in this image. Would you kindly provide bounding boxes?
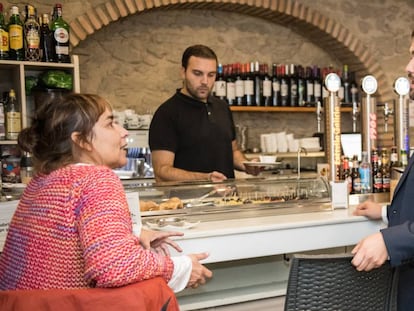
[0,55,80,145]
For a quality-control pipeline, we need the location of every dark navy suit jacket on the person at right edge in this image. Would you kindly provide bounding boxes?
[381,156,414,311]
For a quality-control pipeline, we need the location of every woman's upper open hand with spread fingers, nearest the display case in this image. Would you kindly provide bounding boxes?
[139,229,184,256]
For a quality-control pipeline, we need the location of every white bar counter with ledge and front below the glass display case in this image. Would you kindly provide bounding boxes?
[168,209,384,310]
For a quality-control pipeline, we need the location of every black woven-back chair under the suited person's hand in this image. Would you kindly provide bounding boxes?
[285,254,398,311]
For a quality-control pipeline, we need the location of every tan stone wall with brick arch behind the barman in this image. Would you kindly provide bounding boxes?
[3,0,414,151]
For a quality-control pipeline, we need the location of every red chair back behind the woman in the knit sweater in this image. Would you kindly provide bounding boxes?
[0,278,179,311]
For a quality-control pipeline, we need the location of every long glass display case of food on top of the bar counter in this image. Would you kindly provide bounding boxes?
[125,177,332,228]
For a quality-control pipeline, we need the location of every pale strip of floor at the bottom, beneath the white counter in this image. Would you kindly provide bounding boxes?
[194,297,285,311]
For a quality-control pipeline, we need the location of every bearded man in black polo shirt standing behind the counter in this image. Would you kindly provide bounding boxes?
[149,45,260,181]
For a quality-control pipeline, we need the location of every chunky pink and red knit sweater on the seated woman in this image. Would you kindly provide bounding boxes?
[0,165,173,290]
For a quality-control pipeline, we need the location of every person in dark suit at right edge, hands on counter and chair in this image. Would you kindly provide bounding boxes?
[352,31,414,311]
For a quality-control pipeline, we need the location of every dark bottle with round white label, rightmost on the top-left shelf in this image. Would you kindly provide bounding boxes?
[50,3,70,63]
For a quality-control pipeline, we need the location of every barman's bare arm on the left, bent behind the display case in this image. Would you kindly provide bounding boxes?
[151,150,226,181]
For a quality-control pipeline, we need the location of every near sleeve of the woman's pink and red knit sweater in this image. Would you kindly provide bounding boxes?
[73,167,174,287]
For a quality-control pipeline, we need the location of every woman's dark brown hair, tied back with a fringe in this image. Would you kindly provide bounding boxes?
[18,93,112,174]
